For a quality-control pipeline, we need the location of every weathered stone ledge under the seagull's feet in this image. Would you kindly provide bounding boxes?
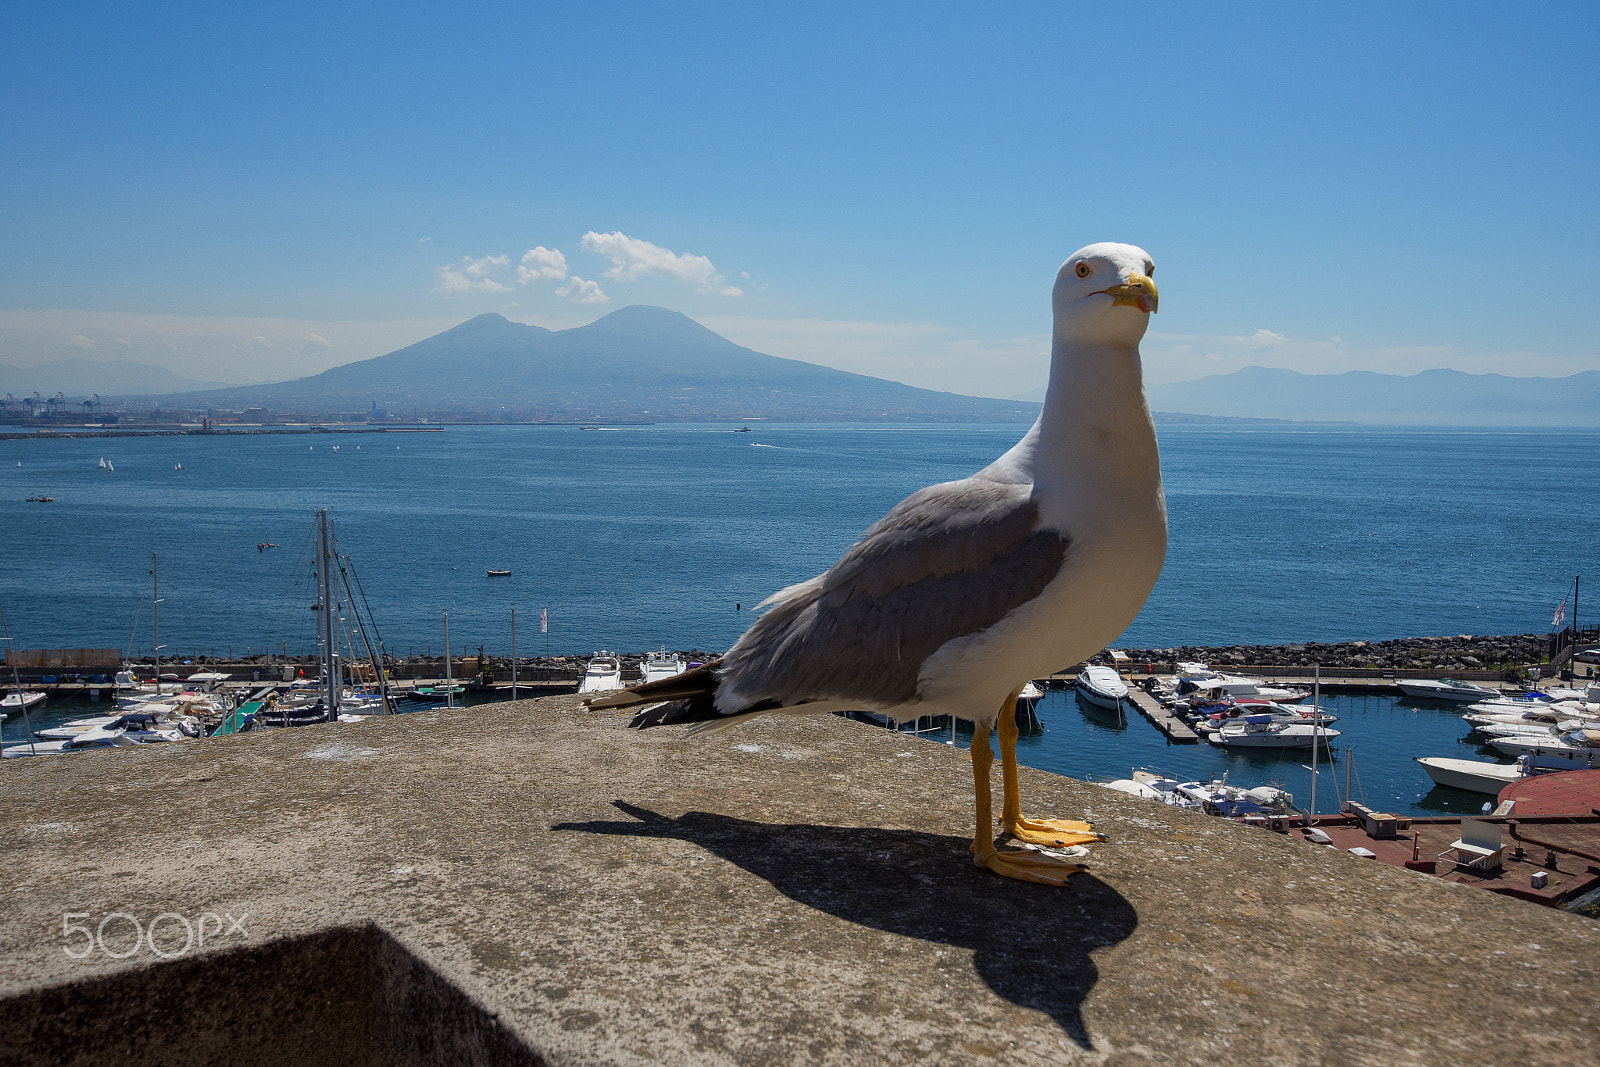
[0,697,1600,1067]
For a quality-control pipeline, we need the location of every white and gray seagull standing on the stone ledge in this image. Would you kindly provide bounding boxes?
[587,243,1166,885]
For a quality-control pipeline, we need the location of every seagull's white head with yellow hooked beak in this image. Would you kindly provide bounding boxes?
[1053,243,1160,344]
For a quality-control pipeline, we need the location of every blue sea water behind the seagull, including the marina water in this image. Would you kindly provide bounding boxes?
[0,421,1600,814]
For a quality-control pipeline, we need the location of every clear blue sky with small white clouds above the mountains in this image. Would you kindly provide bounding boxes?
[0,2,1600,395]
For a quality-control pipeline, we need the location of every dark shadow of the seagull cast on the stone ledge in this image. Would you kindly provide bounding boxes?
[552,800,1139,1049]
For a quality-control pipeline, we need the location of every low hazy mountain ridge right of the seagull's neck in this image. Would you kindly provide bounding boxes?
[1147,366,1600,426]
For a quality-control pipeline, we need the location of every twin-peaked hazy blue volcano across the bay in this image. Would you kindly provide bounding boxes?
[134,306,1038,422]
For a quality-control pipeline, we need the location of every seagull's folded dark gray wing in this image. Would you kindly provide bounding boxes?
[718,478,1070,713]
